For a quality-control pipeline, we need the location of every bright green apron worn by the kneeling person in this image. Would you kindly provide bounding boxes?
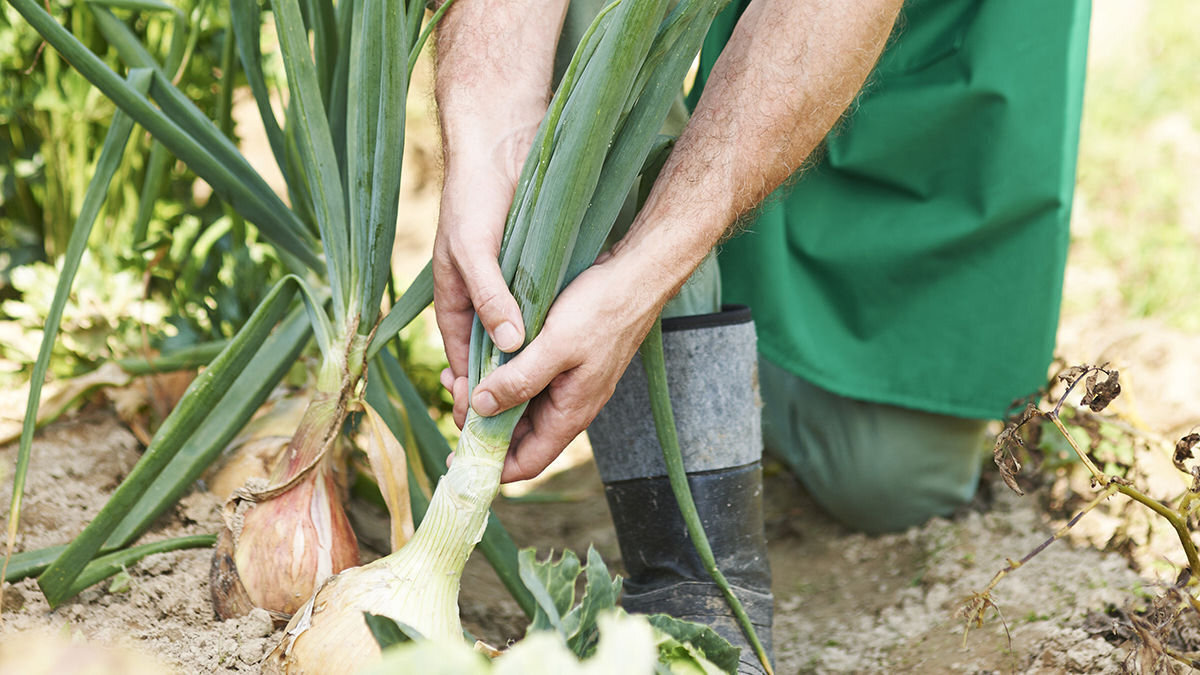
[694,0,1091,418]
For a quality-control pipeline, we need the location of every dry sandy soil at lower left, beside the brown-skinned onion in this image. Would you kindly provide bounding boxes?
[0,408,282,673]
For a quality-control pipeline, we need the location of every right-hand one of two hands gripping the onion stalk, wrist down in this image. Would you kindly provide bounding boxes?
[455,258,661,483]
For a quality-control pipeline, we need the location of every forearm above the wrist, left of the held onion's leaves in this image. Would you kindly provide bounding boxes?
[434,0,566,162]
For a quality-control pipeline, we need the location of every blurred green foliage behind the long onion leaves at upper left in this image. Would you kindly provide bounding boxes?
[0,0,282,341]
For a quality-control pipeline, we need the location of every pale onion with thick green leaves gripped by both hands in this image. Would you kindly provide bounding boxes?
[265,0,725,673]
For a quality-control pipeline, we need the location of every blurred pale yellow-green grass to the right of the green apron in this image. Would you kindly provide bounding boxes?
[1072,0,1200,330]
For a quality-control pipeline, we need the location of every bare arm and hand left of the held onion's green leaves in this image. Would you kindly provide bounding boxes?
[433,0,566,426]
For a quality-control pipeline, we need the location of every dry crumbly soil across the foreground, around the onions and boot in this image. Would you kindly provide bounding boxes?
[0,398,1180,673]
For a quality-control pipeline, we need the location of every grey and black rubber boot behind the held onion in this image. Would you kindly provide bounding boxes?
[588,307,773,673]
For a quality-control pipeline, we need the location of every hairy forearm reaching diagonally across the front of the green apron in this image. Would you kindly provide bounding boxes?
[613,0,901,305]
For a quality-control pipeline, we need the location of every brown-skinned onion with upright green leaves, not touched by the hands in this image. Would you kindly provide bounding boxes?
[211,0,424,617]
